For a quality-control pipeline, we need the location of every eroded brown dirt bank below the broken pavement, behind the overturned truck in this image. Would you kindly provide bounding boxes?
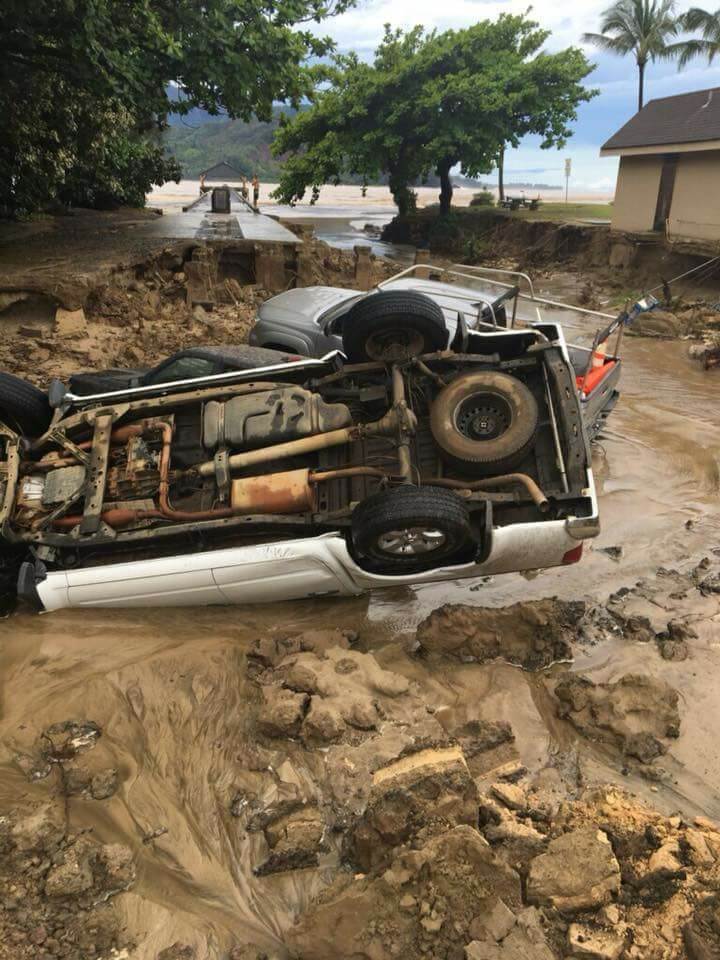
[0,240,396,387]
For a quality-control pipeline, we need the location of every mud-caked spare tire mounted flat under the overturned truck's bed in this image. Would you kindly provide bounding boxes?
[430,371,539,476]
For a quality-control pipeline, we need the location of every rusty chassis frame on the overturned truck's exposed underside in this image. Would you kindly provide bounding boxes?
[0,338,589,549]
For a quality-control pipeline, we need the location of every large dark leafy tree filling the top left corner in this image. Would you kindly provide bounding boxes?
[0,0,353,213]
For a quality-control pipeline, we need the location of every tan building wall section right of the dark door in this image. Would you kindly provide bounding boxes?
[668,150,720,241]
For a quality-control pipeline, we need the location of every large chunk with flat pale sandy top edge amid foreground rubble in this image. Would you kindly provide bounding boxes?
[352,747,477,872]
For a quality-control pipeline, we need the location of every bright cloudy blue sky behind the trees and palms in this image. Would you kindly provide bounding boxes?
[312,0,720,193]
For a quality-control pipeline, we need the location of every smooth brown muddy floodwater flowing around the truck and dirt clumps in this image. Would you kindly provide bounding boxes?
[0,296,720,960]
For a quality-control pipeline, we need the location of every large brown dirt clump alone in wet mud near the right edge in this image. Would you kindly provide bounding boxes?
[555,673,680,763]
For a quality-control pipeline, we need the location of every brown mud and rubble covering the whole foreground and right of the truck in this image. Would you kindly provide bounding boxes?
[0,234,720,960]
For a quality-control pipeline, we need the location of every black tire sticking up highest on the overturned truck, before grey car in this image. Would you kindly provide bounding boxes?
[343,290,448,363]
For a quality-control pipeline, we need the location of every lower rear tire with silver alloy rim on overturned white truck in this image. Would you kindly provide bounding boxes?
[351,485,475,575]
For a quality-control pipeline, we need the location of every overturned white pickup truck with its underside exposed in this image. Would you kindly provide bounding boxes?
[0,290,599,610]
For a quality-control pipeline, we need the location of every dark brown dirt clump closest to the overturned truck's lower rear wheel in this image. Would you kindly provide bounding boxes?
[417,599,585,670]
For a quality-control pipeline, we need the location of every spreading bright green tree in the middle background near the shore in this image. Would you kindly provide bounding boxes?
[274,15,593,216]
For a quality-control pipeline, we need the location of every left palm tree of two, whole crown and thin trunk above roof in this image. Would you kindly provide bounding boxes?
[583,0,681,110]
